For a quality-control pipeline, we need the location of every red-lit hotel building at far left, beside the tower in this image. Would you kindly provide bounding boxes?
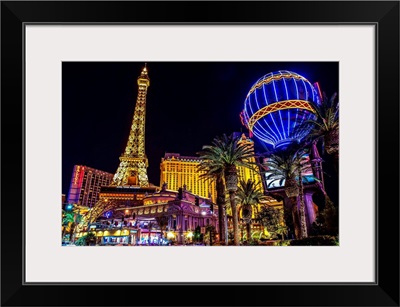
[67,165,114,208]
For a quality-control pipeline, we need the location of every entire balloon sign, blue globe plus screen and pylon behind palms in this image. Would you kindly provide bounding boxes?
[240,70,323,237]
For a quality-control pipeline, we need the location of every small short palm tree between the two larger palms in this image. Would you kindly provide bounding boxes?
[236,179,267,240]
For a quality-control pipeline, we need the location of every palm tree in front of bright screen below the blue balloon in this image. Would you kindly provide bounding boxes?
[264,148,307,238]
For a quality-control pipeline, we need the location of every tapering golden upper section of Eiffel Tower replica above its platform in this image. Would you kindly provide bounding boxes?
[112,65,150,187]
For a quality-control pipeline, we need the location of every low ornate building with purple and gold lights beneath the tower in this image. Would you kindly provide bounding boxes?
[77,185,218,245]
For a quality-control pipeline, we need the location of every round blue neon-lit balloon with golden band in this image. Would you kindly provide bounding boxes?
[241,70,319,148]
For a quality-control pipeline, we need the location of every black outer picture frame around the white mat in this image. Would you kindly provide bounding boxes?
[0,1,400,306]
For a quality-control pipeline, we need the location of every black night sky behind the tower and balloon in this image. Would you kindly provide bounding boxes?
[62,62,339,201]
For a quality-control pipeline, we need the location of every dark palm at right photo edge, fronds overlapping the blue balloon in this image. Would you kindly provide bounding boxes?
[297,93,339,171]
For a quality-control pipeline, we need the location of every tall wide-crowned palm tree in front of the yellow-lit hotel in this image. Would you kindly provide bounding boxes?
[199,134,255,246]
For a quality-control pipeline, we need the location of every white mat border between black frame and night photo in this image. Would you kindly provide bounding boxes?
[25,25,375,283]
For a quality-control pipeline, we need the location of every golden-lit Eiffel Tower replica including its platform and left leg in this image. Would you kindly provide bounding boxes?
[78,64,158,229]
